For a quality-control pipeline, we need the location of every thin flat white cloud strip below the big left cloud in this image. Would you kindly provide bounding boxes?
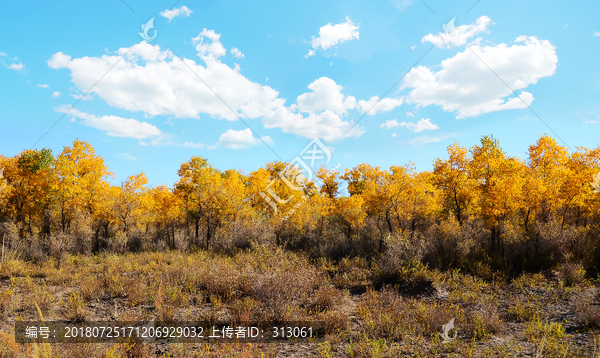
[56,106,162,139]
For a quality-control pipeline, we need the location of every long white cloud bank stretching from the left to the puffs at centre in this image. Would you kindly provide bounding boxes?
[48,33,376,140]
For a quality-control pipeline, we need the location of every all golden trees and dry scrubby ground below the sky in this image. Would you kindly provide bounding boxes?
[0,136,600,358]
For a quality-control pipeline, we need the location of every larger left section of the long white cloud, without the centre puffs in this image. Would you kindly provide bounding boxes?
[48,38,278,120]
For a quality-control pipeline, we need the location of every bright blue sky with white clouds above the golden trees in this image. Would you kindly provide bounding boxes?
[0,0,600,185]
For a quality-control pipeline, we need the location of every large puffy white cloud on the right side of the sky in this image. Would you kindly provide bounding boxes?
[401,36,558,118]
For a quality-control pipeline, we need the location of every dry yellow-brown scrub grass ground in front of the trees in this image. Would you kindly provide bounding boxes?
[0,246,600,358]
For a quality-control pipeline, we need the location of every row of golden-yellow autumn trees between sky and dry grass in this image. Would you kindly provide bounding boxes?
[0,135,600,272]
